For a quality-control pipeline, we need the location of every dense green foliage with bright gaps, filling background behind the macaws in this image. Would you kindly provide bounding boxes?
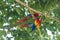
[0,0,60,40]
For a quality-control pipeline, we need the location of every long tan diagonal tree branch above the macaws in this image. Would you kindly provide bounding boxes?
[16,0,60,22]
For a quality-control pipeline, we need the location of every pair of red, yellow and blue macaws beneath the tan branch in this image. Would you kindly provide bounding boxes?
[17,13,42,31]
